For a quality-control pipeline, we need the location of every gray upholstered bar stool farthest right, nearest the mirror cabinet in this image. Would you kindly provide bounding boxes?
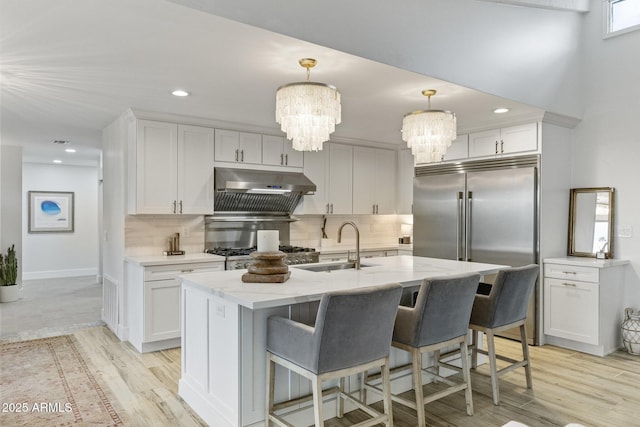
[469,264,539,405]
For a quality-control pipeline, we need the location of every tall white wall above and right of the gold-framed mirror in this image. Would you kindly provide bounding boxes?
[572,5,640,308]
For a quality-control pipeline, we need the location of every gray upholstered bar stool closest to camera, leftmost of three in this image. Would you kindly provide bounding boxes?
[266,284,402,427]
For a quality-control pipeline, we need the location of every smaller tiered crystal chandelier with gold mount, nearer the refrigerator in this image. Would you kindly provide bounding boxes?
[402,89,456,165]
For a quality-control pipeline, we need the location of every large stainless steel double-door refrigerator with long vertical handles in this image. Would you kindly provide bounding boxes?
[413,155,540,344]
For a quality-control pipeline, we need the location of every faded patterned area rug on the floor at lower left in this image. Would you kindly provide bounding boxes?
[0,335,126,427]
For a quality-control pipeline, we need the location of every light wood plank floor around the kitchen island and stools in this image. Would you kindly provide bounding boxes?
[73,327,640,427]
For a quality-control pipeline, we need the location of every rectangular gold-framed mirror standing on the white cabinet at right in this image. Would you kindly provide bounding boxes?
[568,187,614,258]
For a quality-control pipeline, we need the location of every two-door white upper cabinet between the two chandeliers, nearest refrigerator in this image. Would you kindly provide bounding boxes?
[353,147,396,214]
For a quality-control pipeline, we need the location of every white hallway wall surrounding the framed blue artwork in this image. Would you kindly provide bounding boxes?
[22,163,99,280]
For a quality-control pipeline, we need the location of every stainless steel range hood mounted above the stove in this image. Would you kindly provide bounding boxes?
[214,168,316,215]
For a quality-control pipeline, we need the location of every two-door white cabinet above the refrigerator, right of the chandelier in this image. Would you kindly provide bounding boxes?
[469,123,538,157]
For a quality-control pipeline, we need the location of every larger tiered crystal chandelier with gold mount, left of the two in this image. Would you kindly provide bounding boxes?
[276,58,342,151]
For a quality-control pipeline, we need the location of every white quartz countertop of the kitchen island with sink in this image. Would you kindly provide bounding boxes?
[180,255,508,310]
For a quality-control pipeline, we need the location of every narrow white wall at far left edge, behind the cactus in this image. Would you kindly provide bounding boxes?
[0,145,23,283]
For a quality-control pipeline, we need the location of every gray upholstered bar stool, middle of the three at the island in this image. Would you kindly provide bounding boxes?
[367,273,480,426]
